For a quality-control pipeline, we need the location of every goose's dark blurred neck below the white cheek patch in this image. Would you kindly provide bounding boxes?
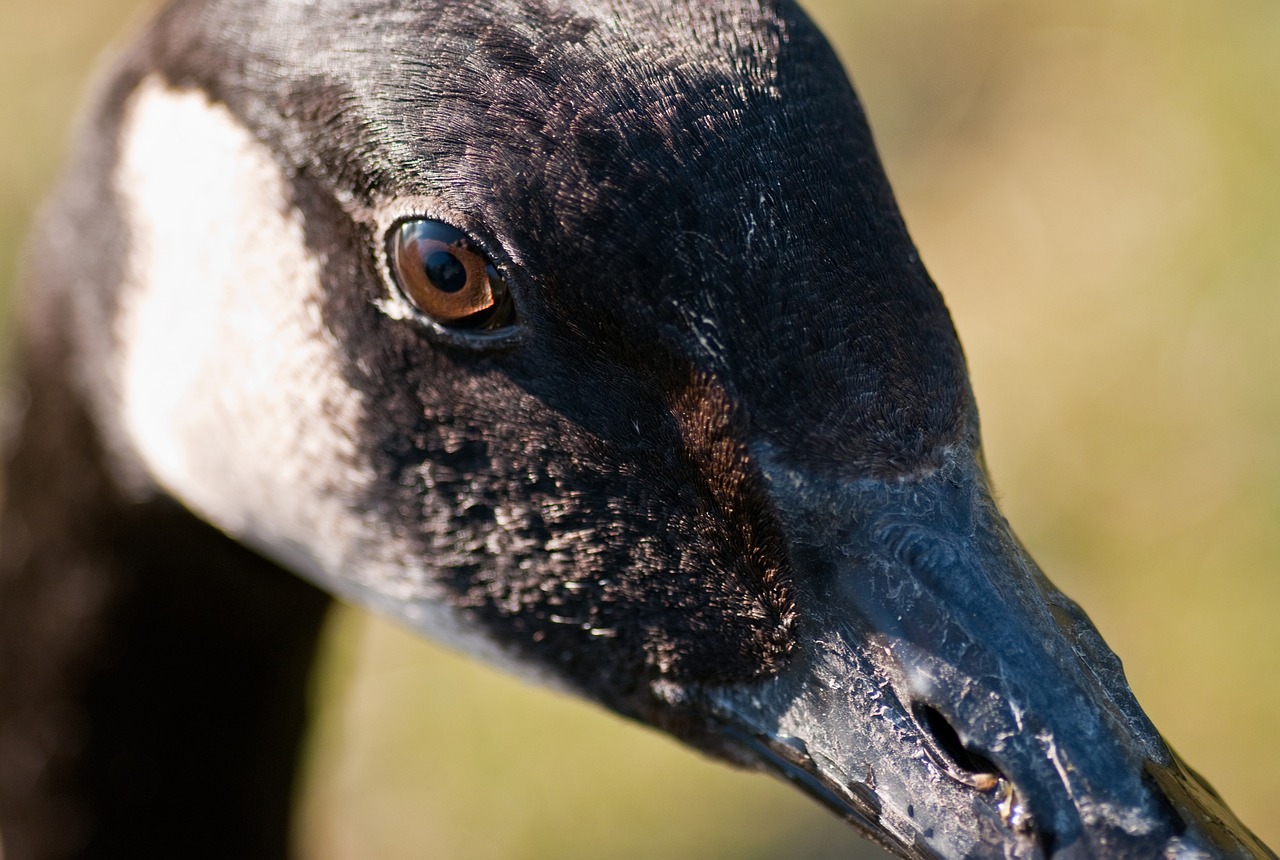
[0,322,329,860]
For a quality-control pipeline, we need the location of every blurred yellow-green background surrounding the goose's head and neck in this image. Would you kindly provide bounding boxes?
[0,0,1280,860]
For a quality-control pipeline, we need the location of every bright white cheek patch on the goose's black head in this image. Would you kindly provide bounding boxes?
[115,78,547,680]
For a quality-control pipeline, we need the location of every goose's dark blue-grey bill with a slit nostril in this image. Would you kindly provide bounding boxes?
[703,461,1275,857]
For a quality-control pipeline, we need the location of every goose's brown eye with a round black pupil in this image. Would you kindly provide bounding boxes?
[388,220,515,331]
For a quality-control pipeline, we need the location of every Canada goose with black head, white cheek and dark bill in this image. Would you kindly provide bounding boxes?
[0,3,1271,856]
